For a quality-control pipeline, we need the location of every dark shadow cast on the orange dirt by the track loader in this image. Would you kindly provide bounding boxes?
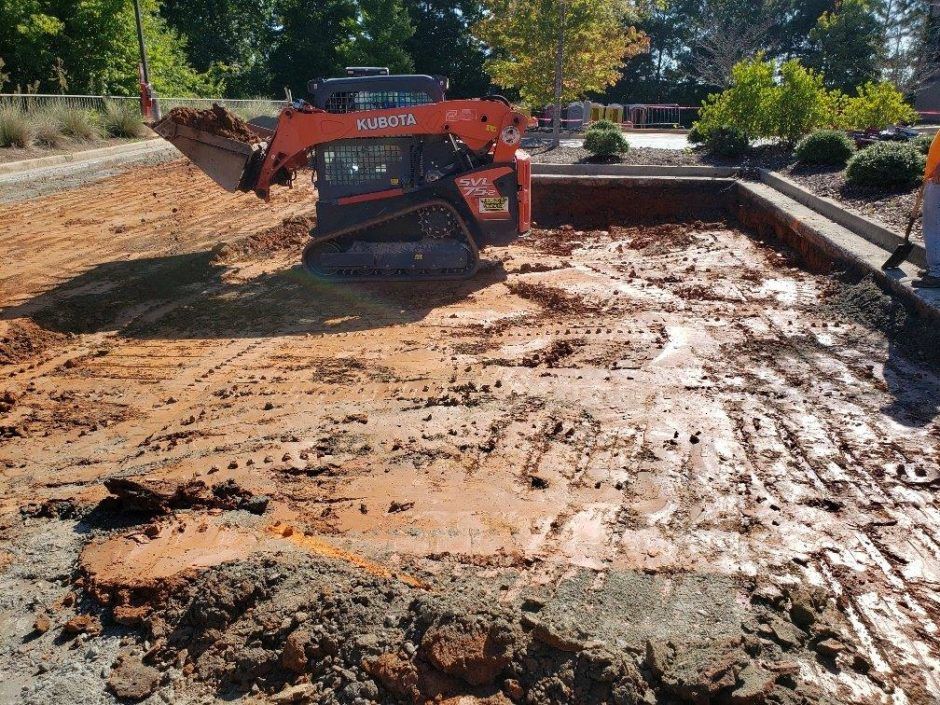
[0,251,506,339]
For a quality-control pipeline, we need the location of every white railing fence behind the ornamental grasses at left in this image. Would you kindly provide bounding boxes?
[0,93,287,117]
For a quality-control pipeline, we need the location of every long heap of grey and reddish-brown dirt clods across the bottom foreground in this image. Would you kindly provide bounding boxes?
[71,554,859,705]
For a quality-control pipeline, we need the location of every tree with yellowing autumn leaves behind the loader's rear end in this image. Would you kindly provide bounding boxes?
[476,0,649,107]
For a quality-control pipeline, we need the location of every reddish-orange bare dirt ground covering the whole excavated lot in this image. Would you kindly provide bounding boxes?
[0,161,940,705]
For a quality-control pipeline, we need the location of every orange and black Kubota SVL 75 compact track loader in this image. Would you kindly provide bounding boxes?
[154,69,531,281]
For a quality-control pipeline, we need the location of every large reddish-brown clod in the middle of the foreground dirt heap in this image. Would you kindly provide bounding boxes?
[421,619,514,685]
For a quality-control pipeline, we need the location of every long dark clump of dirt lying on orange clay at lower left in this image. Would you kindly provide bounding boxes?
[104,477,270,514]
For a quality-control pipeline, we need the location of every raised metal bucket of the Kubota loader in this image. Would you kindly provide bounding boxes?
[153,120,264,191]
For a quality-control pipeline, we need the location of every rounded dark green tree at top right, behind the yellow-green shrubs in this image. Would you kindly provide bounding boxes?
[806,0,884,92]
